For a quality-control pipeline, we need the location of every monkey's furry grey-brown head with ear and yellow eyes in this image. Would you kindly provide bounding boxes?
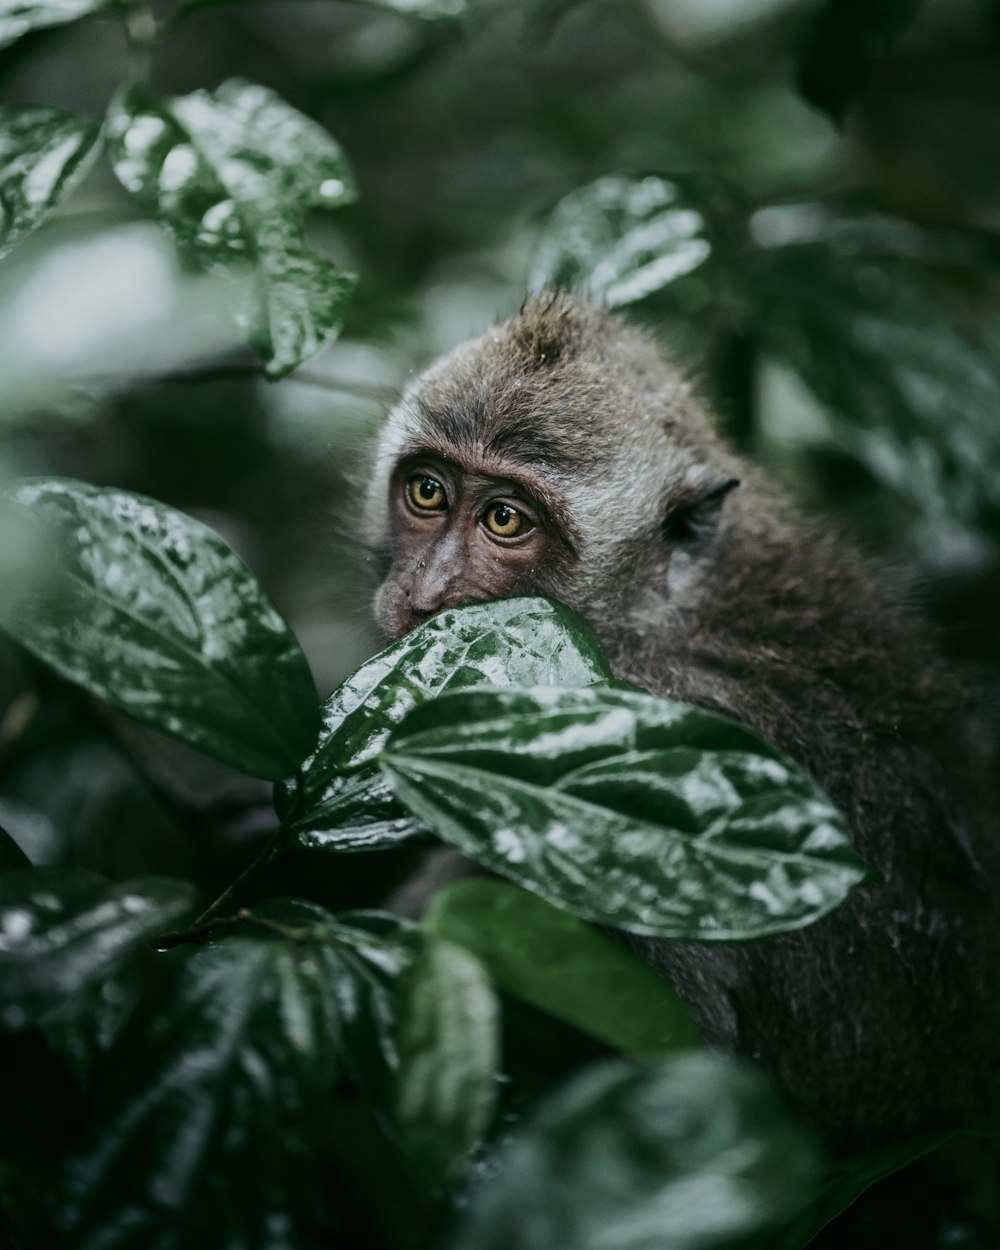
[368,295,738,638]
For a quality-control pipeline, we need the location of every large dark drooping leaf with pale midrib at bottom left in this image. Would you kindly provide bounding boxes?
[61,929,347,1250]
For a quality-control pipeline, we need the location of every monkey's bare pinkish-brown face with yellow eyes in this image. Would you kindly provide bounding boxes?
[375,451,573,639]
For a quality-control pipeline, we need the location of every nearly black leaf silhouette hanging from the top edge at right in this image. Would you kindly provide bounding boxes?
[799,0,924,121]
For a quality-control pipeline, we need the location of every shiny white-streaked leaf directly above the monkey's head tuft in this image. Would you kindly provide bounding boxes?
[529,178,713,309]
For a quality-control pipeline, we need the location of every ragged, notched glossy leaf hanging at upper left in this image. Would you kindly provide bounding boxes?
[108,79,355,378]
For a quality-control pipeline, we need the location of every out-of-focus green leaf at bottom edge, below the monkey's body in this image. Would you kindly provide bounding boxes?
[450,1055,818,1250]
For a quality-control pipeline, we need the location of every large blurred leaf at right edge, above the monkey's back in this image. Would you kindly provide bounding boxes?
[754,243,1000,526]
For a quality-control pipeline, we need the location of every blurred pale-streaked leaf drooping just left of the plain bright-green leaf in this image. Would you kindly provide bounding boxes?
[308,913,498,1193]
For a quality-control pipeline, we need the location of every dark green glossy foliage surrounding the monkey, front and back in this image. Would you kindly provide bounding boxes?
[0,0,1000,1250]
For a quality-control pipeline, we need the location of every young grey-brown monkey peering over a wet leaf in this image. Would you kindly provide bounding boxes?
[365,293,1000,1151]
